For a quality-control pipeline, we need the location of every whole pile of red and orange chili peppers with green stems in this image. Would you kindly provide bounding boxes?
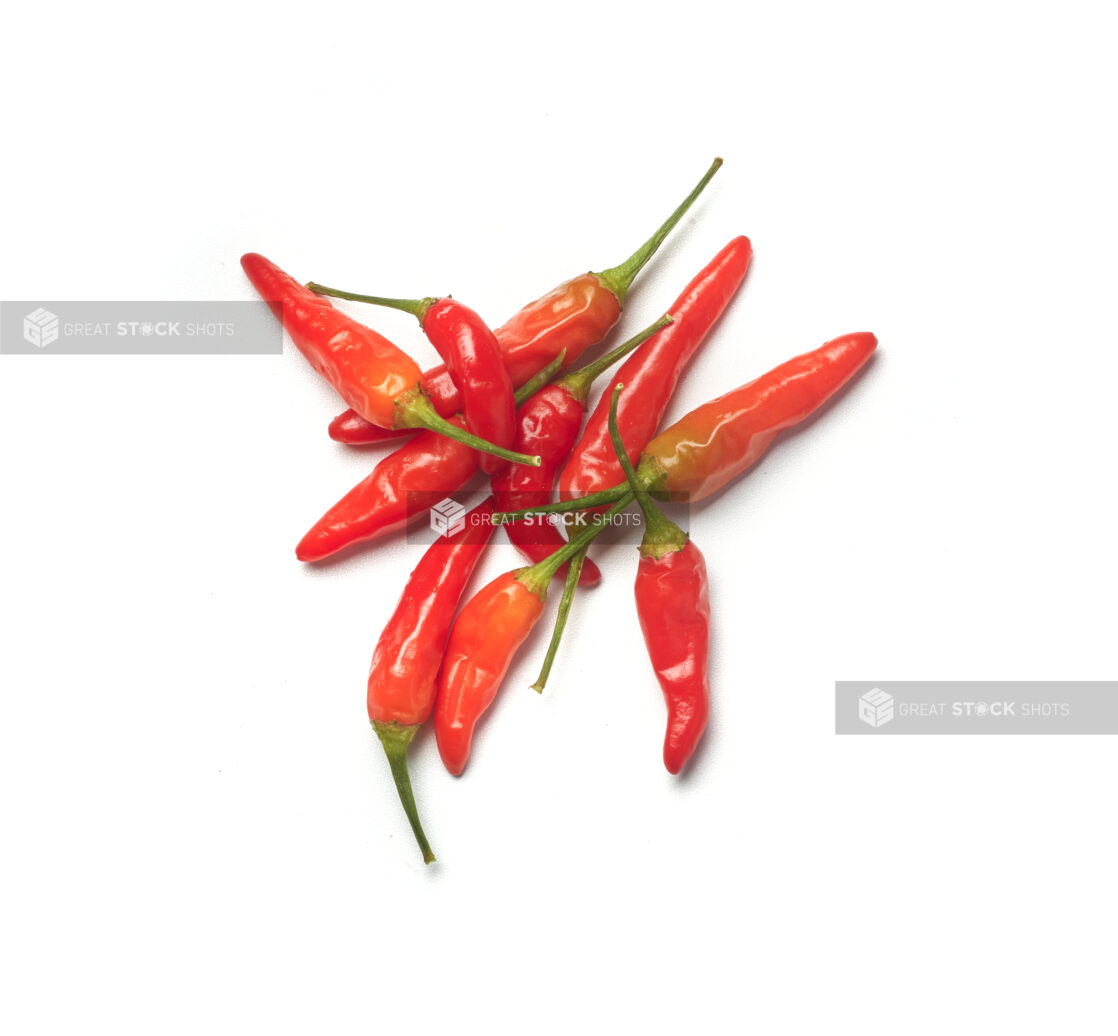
[249,159,877,863]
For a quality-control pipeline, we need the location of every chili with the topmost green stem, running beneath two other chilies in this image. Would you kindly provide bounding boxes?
[331,159,722,445]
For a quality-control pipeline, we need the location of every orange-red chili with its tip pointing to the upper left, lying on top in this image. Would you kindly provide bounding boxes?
[240,253,540,464]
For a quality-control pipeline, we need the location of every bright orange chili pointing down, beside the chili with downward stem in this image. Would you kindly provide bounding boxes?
[435,505,624,776]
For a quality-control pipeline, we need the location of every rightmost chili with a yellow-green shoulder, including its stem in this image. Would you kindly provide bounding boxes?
[494,331,878,522]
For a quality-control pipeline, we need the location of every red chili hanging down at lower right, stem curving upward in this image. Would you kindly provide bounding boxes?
[608,384,710,773]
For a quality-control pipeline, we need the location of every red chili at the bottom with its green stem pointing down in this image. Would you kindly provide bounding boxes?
[367,496,495,863]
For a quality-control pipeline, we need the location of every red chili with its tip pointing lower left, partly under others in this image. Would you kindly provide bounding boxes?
[295,359,559,561]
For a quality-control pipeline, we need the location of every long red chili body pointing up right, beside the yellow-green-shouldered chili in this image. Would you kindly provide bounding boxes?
[559,237,752,509]
